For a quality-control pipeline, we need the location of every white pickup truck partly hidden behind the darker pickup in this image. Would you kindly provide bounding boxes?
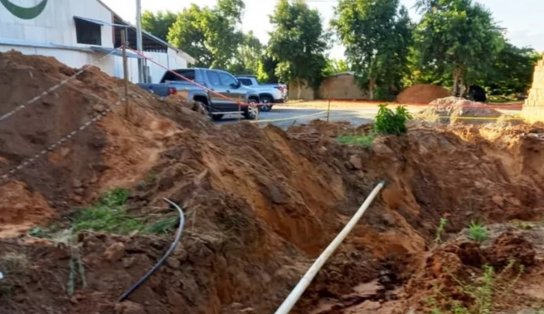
[236,75,288,111]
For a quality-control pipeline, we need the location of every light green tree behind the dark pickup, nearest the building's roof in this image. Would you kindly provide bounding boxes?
[168,0,244,69]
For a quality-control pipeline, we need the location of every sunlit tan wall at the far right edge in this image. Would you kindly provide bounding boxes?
[522,59,544,122]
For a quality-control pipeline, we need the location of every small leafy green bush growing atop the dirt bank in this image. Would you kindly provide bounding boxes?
[374,104,412,135]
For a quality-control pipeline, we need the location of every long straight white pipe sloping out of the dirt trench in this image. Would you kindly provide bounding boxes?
[275,181,385,314]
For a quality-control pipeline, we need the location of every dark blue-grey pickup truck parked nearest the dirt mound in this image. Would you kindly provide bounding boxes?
[138,68,259,120]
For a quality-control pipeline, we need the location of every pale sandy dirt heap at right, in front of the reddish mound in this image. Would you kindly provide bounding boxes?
[417,97,502,124]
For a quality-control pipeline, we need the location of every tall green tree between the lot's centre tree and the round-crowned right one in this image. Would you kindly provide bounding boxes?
[332,0,412,99]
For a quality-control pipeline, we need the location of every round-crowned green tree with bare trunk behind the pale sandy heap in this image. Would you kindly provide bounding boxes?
[415,0,505,96]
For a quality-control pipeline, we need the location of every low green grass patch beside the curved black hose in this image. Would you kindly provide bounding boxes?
[73,189,144,234]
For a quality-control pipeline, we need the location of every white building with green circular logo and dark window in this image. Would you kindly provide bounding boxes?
[0,0,194,82]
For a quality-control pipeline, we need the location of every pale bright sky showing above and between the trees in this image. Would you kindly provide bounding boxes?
[102,0,544,58]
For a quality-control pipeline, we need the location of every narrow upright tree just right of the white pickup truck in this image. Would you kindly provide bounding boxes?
[269,0,328,97]
